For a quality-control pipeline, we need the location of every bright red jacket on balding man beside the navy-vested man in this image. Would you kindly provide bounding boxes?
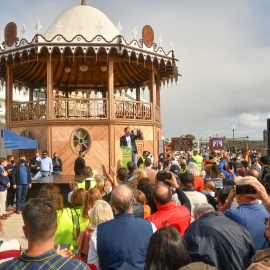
[147,201,190,236]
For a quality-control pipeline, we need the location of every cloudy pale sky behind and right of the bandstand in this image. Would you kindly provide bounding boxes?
[0,0,270,139]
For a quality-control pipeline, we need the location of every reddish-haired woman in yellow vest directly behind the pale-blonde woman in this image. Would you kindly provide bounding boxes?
[76,188,102,239]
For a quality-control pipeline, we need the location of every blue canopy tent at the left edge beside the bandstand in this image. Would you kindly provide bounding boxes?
[4,129,38,150]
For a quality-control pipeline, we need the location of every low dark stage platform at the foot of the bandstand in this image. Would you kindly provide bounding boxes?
[27,175,83,207]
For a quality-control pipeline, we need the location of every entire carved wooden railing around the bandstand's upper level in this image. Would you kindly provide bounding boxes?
[10,98,160,122]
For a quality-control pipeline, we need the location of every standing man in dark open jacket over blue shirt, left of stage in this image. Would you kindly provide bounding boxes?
[12,155,32,214]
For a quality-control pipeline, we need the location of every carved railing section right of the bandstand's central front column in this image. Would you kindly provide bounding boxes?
[115,100,152,120]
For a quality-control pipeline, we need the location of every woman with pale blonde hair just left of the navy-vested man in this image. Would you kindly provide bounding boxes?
[77,200,113,262]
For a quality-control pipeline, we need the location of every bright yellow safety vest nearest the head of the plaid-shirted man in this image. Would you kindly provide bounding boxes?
[54,208,73,246]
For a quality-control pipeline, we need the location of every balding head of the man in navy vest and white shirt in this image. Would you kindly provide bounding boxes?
[111,185,134,214]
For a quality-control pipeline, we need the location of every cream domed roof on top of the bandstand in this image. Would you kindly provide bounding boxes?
[43,5,119,41]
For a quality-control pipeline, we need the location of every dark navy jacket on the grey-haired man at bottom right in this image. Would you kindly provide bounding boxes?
[184,211,255,270]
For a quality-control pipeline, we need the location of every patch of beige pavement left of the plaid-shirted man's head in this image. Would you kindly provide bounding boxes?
[1,212,27,251]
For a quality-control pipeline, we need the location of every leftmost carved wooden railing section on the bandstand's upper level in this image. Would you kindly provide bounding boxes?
[10,100,46,122]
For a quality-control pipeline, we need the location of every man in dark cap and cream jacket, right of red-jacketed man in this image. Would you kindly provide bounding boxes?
[179,173,207,223]
